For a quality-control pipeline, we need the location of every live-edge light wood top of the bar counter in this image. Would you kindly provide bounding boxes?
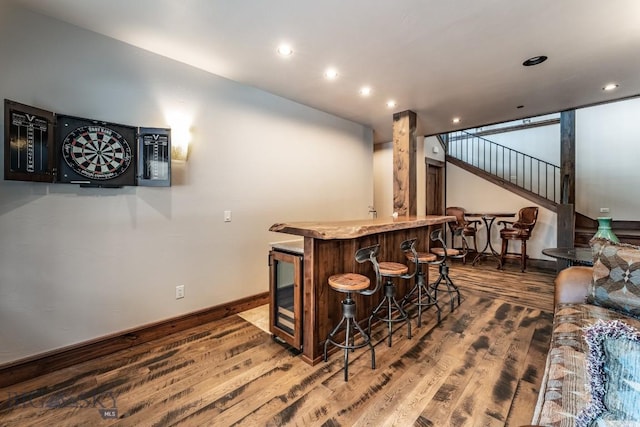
[269,215,456,240]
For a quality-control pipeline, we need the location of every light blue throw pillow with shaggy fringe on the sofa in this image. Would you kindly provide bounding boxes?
[576,320,640,427]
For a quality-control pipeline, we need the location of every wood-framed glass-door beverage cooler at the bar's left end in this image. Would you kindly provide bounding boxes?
[269,240,304,351]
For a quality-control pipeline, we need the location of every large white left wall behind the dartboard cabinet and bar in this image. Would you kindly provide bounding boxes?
[0,2,373,363]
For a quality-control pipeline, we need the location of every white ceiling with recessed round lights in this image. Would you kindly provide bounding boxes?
[16,0,640,142]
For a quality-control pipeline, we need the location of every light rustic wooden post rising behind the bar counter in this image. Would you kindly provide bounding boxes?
[393,110,418,216]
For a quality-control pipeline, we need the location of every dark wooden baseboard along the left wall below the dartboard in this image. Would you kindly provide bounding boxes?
[0,292,269,388]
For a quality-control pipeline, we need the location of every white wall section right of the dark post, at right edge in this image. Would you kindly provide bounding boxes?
[576,98,640,221]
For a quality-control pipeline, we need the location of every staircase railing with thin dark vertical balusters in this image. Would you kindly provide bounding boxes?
[441,131,560,212]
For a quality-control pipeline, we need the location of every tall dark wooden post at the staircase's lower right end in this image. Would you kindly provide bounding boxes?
[556,110,576,271]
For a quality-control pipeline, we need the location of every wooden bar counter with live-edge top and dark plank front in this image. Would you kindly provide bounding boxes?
[269,215,456,365]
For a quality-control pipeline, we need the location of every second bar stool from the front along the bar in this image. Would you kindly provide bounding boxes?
[367,238,417,347]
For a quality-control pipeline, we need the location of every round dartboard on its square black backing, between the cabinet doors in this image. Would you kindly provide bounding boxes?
[58,116,136,185]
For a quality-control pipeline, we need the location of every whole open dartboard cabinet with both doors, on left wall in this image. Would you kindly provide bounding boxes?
[4,100,171,188]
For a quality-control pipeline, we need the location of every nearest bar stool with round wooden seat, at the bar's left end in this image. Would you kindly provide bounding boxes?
[324,245,382,381]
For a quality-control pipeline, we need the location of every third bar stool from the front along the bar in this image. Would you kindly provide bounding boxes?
[402,231,443,327]
